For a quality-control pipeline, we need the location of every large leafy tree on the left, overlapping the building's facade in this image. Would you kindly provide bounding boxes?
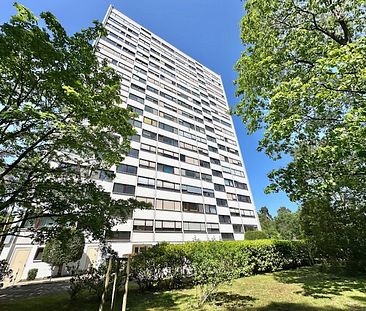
[0,3,147,238]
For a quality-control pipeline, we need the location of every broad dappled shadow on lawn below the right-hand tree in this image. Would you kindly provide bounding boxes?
[274,267,366,298]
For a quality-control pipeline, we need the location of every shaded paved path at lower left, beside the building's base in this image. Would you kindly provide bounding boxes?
[0,281,70,302]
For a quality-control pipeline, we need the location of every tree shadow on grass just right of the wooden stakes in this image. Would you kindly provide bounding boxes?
[127,291,192,311]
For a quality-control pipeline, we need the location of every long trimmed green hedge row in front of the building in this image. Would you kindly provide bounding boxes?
[131,240,312,290]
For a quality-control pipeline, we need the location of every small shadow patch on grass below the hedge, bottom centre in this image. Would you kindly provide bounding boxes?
[209,292,257,311]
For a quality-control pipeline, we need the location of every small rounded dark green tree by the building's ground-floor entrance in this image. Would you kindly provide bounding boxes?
[42,228,85,275]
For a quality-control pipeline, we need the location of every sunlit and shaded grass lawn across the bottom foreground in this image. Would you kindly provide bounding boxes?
[0,267,366,311]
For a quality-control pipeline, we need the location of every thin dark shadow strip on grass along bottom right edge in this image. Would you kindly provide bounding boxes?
[255,302,365,311]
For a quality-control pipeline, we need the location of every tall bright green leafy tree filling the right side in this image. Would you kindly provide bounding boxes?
[234,0,366,262]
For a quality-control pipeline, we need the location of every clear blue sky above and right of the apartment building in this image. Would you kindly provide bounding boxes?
[0,0,296,214]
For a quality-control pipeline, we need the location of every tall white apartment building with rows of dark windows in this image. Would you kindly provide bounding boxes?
[1,7,260,278]
